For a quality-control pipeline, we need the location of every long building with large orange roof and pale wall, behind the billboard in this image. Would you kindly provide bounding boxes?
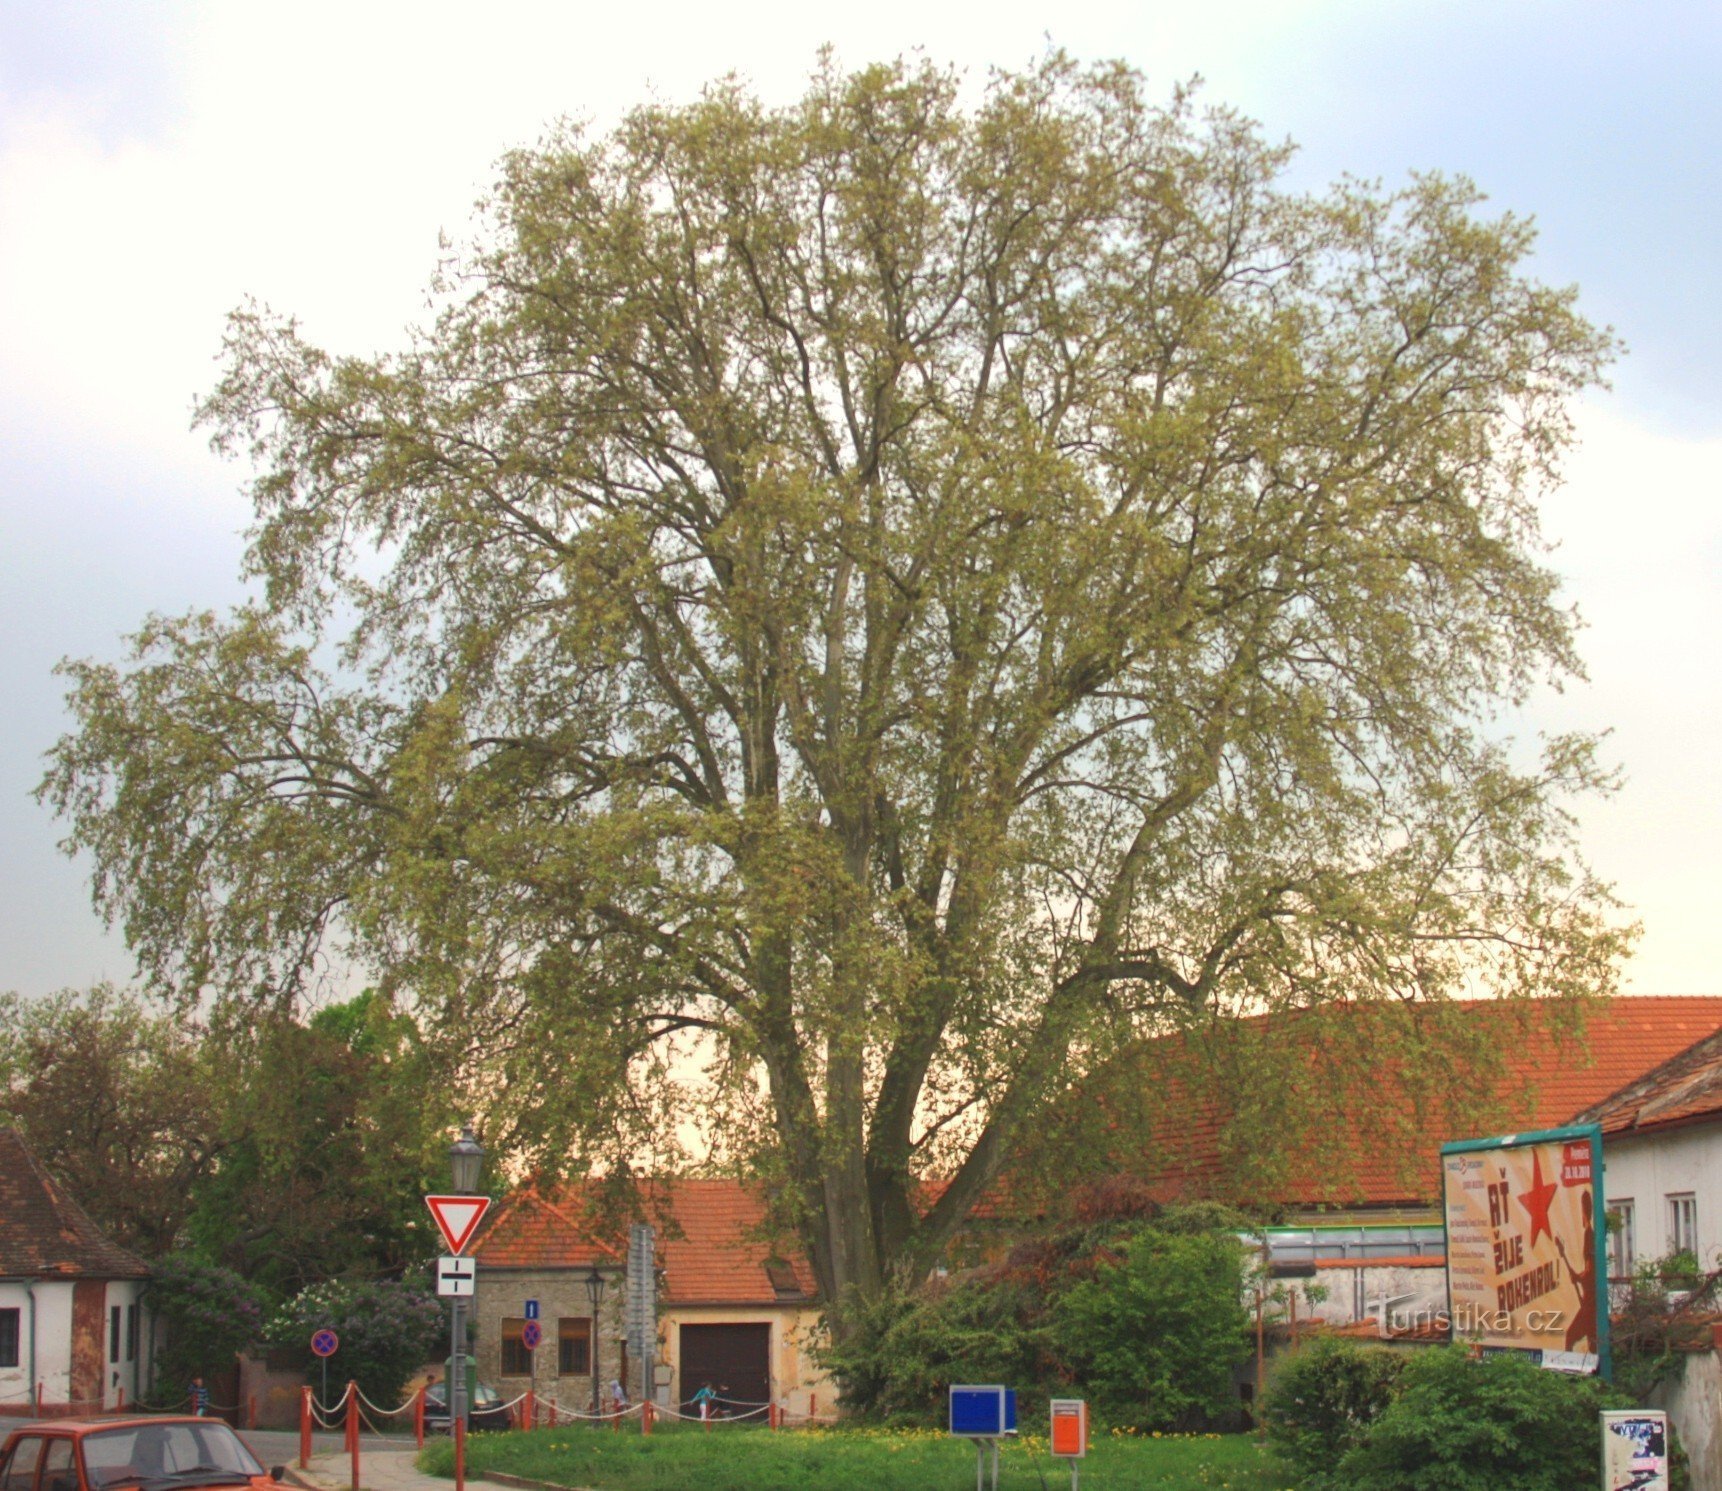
[1060,995,1722,1327]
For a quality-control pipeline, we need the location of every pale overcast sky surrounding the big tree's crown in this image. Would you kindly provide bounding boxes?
[0,0,1722,993]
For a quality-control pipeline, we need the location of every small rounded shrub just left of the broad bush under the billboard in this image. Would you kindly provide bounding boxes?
[1262,1339,1409,1484]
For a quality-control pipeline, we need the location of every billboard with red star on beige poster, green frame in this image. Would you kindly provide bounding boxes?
[1441,1124,1608,1376]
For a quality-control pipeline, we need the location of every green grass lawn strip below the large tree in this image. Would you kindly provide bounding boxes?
[418,1424,1290,1491]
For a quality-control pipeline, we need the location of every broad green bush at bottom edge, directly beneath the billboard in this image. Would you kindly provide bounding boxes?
[1331,1346,1631,1491]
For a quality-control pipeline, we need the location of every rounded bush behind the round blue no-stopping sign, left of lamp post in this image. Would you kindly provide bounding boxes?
[269,1279,448,1408]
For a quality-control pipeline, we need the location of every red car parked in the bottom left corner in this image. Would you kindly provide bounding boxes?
[0,1417,281,1491]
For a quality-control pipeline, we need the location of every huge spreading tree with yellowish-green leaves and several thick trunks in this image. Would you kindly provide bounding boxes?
[43,55,1622,1298]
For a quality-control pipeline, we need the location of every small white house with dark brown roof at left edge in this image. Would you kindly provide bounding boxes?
[0,1129,150,1414]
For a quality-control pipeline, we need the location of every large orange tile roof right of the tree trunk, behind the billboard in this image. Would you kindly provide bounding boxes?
[1114,995,1722,1207]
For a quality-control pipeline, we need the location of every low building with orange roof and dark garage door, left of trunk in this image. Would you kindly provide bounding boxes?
[470,1178,835,1415]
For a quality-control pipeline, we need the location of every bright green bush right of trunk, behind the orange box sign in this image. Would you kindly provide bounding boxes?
[1054,1229,1248,1429]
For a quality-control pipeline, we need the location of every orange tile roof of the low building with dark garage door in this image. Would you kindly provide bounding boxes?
[472,1179,815,1305]
